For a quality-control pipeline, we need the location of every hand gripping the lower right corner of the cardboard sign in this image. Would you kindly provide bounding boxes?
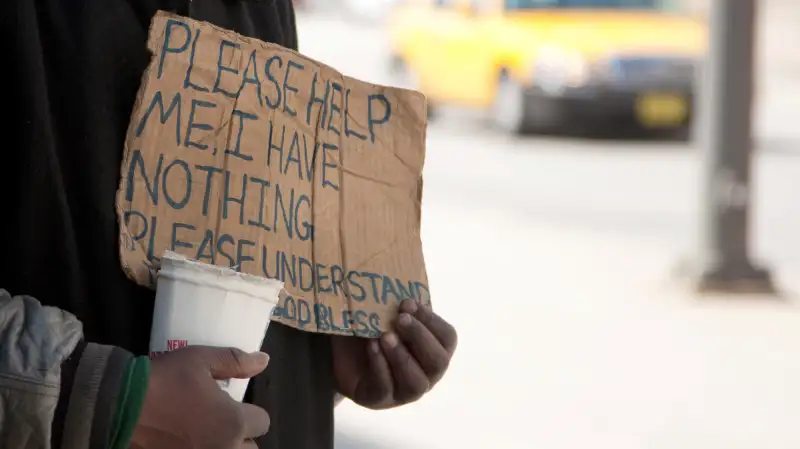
[333,301,458,409]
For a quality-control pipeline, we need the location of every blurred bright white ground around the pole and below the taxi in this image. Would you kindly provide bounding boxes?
[300,13,800,449]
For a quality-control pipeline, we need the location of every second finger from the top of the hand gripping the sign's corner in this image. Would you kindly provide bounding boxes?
[396,313,450,384]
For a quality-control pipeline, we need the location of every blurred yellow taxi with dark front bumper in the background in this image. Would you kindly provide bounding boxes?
[387,0,707,133]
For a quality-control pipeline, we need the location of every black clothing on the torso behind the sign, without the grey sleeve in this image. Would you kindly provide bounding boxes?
[0,0,334,449]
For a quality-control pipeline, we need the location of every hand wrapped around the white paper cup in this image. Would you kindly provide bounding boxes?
[131,346,270,449]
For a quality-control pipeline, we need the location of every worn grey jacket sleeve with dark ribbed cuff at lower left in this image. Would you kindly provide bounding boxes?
[0,289,132,449]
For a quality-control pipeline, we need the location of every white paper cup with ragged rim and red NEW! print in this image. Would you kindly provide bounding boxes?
[150,252,283,401]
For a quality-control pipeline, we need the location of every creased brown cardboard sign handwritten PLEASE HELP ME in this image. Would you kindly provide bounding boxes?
[116,12,430,337]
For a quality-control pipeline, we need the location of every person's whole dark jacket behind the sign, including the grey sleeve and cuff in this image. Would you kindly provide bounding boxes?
[0,0,334,449]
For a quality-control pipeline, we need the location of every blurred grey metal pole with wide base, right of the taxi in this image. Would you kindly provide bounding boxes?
[698,0,774,293]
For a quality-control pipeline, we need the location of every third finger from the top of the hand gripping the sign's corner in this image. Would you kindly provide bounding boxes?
[381,332,430,403]
